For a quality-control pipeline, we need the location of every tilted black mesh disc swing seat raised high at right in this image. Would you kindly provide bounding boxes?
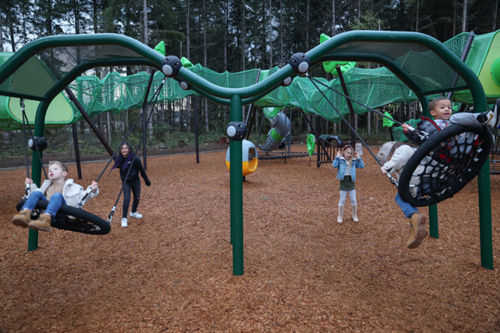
[398,125,493,207]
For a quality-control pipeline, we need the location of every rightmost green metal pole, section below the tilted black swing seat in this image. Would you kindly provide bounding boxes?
[478,158,493,269]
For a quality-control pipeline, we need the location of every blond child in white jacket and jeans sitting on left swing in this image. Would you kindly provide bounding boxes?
[12,161,99,231]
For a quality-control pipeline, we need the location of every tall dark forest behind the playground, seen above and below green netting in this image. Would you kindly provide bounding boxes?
[0,0,500,156]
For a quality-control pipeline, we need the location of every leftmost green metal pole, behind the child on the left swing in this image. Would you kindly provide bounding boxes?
[28,102,50,251]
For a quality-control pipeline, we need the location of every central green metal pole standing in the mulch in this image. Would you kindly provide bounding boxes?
[229,95,243,275]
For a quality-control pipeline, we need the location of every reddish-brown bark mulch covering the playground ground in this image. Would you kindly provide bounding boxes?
[0,145,500,332]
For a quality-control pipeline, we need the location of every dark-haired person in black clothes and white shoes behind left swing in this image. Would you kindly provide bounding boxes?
[111,142,151,227]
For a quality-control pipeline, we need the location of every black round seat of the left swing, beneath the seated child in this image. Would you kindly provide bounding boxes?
[16,200,111,235]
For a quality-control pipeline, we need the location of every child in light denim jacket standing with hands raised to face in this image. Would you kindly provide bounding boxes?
[332,145,365,223]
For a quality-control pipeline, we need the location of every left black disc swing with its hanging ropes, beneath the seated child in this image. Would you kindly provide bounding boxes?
[16,99,111,235]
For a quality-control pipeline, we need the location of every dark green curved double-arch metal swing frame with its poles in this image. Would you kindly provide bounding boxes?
[0,31,493,275]
